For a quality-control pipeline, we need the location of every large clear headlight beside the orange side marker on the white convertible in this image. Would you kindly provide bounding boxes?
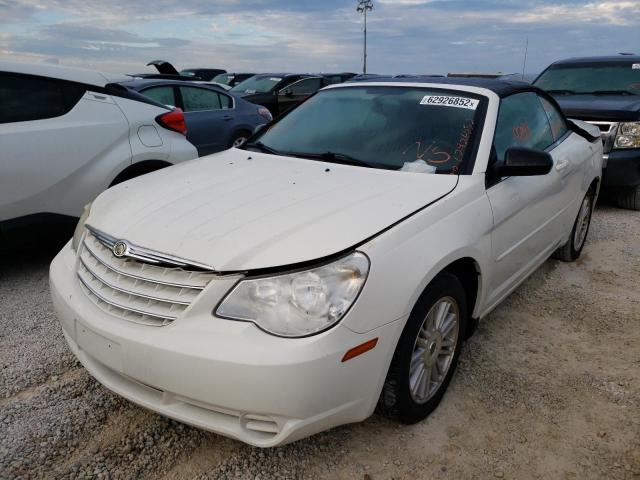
[216,252,369,337]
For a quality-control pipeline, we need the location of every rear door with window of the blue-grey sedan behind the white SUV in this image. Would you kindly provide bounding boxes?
[178,85,235,156]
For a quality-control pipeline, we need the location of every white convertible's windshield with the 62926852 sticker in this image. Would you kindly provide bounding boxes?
[246,86,487,174]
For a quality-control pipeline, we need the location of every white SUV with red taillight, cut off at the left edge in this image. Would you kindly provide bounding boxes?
[0,62,198,229]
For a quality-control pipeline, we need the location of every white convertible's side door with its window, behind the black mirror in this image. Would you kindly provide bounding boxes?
[487,92,575,304]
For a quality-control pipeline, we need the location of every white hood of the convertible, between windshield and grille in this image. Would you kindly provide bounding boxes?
[87,149,457,272]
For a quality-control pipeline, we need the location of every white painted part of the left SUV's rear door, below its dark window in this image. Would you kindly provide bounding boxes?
[0,92,132,220]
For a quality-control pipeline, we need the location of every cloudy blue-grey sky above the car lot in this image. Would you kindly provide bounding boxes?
[0,0,640,74]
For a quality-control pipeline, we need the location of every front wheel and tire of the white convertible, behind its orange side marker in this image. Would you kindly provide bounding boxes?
[378,272,468,424]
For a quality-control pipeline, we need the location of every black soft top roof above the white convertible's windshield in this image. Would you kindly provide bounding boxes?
[347,76,547,97]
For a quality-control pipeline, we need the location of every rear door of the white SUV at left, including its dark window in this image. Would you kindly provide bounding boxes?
[0,72,131,221]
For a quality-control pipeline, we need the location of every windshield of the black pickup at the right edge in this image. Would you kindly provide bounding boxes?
[535,62,640,95]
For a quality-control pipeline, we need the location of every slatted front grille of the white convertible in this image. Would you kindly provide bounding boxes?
[77,229,215,326]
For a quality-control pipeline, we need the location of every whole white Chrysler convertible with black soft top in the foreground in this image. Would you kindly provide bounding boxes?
[51,78,602,447]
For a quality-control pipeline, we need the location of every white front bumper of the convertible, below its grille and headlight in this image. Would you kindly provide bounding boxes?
[50,244,404,447]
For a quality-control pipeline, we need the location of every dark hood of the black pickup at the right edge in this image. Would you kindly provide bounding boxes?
[554,95,640,122]
